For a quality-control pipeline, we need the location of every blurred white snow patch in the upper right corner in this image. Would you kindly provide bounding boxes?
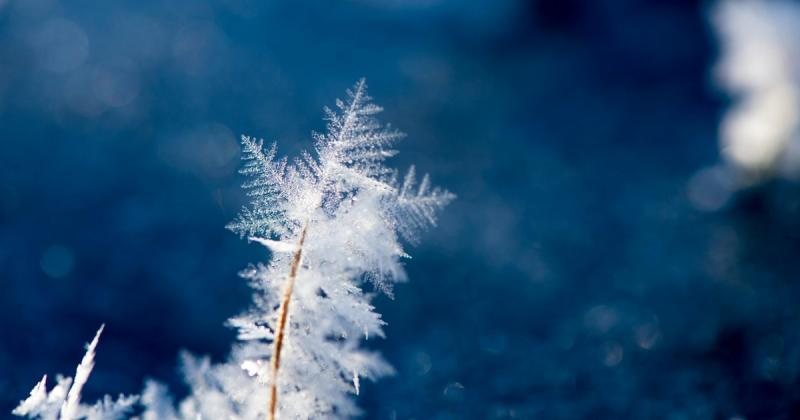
[712,0,800,187]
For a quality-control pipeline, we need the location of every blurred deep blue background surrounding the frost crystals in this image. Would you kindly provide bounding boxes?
[0,0,800,419]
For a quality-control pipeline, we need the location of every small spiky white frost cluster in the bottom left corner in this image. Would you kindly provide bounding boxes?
[12,325,138,420]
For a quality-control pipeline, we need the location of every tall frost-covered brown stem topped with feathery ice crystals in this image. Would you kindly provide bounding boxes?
[144,79,454,419]
